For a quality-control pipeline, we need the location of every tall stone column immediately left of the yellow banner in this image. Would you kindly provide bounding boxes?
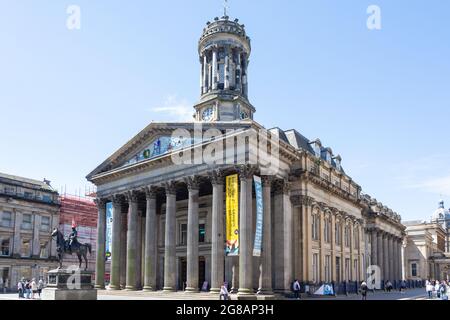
[210,170,225,294]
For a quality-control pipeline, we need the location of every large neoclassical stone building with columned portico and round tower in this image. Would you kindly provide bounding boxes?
[87,16,404,298]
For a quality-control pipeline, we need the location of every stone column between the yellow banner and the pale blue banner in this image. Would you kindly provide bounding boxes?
[238,165,254,298]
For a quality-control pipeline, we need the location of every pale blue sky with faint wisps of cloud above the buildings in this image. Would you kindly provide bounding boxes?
[0,0,450,220]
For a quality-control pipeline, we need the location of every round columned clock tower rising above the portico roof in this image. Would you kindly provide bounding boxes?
[194,14,255,122]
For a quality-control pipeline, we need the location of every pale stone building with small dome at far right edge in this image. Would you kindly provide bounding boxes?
[404,200,450,281]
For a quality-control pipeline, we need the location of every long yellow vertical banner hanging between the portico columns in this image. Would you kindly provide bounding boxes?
[226,174,239,256]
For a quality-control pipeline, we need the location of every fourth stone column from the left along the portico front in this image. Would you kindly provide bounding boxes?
[144,187,157,291]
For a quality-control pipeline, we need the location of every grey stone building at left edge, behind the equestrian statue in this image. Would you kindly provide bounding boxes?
[0,173,60,290]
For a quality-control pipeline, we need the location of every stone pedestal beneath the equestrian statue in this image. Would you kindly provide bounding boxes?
[42,269,97,300]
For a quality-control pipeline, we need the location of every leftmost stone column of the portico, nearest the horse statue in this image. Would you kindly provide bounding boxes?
[95,199,106,289]
